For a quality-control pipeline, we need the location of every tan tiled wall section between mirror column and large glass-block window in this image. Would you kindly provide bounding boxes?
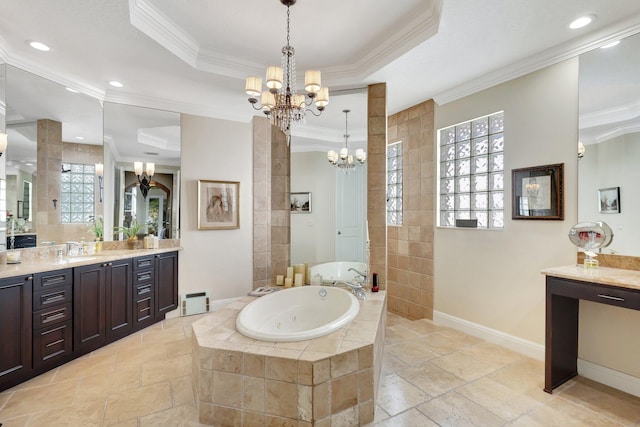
[387,101,435,319]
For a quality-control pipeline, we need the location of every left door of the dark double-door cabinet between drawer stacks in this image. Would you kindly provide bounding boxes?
[73,264,106,355]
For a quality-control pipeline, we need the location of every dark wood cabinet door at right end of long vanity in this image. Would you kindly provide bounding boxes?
[155,252,178,320]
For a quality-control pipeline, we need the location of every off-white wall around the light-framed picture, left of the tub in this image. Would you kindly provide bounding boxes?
[178,114,253,300]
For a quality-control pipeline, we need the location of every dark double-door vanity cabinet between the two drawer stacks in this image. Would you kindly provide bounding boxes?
[73,259,133,355]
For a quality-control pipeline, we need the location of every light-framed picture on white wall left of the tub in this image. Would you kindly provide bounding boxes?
[198,179,240,230]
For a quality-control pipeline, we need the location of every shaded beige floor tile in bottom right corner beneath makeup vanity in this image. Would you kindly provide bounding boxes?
[554,377,640,424]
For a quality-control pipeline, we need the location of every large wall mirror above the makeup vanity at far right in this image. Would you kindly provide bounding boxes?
[578,34,640,256]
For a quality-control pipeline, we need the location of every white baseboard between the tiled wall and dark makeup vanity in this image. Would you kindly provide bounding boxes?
[433,310,544,360]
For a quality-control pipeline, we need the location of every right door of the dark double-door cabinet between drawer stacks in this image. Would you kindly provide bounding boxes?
[106,259,133,341]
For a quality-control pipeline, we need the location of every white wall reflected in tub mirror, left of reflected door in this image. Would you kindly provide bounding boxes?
[291,151,336,265]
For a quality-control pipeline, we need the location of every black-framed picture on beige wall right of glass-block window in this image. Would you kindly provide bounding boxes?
[511,163,564,220]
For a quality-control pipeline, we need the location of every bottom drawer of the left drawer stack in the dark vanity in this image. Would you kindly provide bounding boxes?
[33,320,73,369]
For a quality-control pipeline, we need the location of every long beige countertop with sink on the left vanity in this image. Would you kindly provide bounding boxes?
[0,247,182,279]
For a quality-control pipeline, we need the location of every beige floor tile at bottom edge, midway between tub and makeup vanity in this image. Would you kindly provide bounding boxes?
[418,392,505,427]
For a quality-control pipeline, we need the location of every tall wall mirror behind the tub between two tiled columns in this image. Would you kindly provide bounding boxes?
[290,88,368,264]
